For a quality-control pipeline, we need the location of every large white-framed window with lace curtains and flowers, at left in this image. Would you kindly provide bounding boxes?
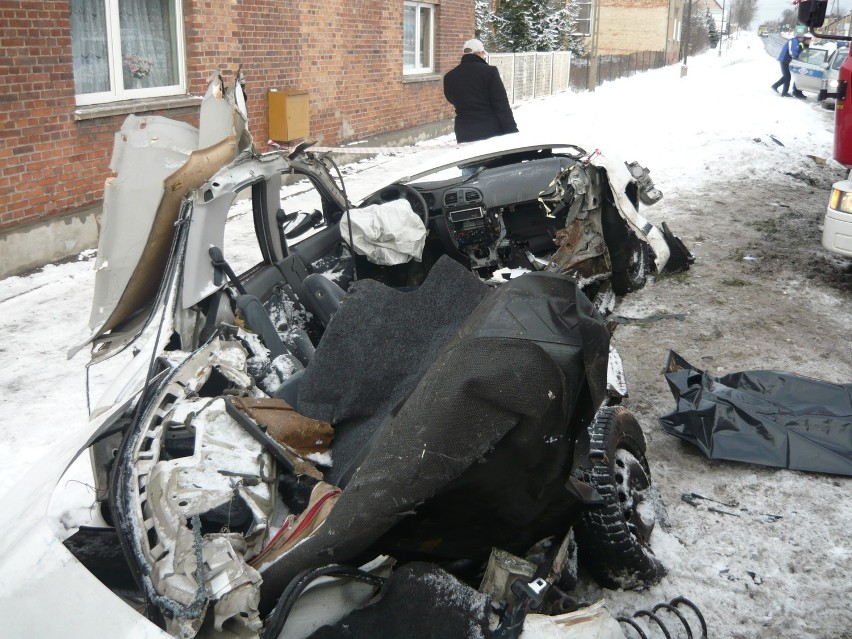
[70,0,186,105]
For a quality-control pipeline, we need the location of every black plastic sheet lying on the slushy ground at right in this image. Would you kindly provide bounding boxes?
[660,351,852,475]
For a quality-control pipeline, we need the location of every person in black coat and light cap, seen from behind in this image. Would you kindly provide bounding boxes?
[444,40,518,142]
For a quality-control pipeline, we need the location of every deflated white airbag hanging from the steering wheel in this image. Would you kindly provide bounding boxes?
[340,199,426,266]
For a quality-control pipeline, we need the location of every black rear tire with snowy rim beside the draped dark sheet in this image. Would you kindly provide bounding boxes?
[577,406,666,590]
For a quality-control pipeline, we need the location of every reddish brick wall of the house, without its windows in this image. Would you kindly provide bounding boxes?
[0,0,473,231]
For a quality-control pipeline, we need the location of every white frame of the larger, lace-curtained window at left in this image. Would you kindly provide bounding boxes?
[69,0,187,107]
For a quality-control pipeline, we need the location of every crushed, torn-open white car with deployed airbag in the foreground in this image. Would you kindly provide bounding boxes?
[0,76,689,637]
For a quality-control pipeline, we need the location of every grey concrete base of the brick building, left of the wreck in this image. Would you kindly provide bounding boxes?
[0,204,101,278]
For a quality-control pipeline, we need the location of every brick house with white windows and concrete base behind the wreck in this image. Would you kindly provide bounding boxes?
[0,0,474,276]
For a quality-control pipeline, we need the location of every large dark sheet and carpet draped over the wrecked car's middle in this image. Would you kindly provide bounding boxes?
[261,258,609,608]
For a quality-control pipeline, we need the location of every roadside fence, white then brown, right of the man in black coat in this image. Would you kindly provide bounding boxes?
[488,51,666,104]
